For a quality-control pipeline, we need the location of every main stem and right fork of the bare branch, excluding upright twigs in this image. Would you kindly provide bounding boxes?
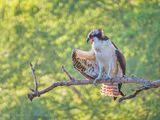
[28,77,160,102]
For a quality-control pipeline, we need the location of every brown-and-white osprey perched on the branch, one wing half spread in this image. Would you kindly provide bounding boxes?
[72,29,126,100]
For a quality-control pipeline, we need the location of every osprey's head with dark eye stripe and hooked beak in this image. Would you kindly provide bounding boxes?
[86,29,108,44]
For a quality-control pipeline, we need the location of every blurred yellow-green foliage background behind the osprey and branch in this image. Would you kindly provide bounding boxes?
[0,0,160,120]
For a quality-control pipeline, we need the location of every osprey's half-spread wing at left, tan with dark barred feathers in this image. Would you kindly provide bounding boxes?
[72,49,98,80]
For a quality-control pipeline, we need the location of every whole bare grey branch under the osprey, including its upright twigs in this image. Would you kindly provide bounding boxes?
[28,66,160,102]
